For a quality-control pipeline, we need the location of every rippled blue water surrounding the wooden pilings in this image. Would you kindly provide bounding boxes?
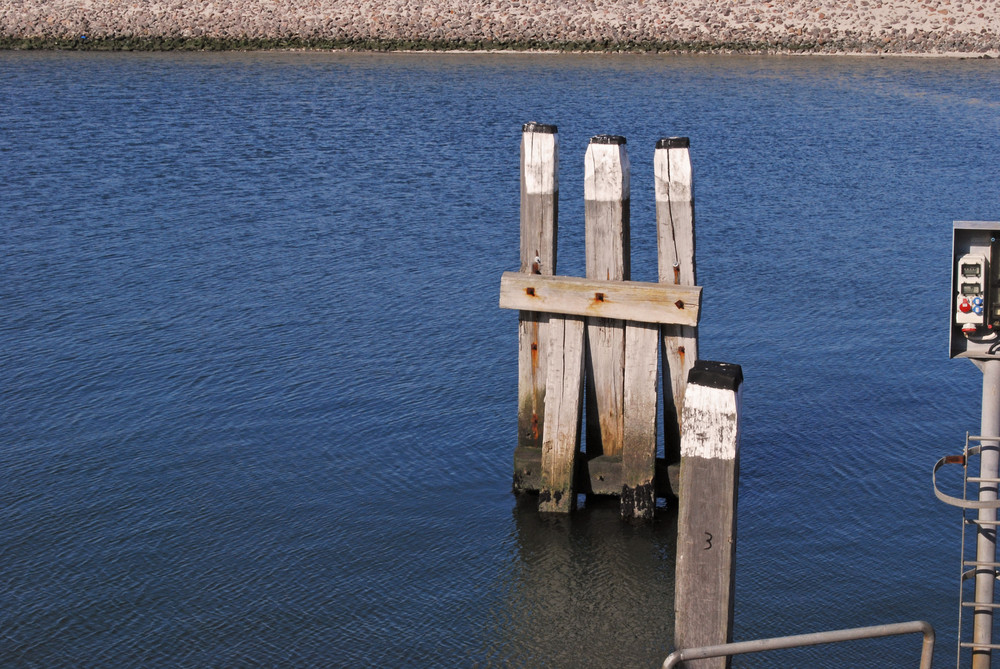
[0,52,1000,667]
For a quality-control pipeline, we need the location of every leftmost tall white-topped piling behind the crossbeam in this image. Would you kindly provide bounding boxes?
[513,123,559,493]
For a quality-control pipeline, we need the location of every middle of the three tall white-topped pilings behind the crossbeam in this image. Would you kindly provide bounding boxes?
[584,135,630,458]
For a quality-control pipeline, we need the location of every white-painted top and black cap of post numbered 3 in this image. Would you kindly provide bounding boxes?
[681,360,743,460]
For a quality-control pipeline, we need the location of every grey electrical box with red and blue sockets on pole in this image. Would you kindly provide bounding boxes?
[949,221,1000,358]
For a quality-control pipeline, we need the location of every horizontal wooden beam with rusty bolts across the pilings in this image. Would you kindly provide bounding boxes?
[500,272,701,325]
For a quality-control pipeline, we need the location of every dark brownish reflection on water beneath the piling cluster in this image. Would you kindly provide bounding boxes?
[489,495,677,667]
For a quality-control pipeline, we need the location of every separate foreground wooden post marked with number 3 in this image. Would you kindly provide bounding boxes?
[674,360,743,669]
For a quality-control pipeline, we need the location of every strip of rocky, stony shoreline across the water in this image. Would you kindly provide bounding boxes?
[0,0,1000,57]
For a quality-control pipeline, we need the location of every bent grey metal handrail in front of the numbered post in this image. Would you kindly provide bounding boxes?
[663,620,934,669]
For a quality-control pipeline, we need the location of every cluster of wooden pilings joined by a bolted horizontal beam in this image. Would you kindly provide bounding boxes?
[500,123,701,519]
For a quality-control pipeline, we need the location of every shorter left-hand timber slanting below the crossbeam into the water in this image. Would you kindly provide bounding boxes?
[538,315,584,513]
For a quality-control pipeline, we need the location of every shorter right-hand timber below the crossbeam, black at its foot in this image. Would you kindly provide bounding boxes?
[621,321,660,520]
